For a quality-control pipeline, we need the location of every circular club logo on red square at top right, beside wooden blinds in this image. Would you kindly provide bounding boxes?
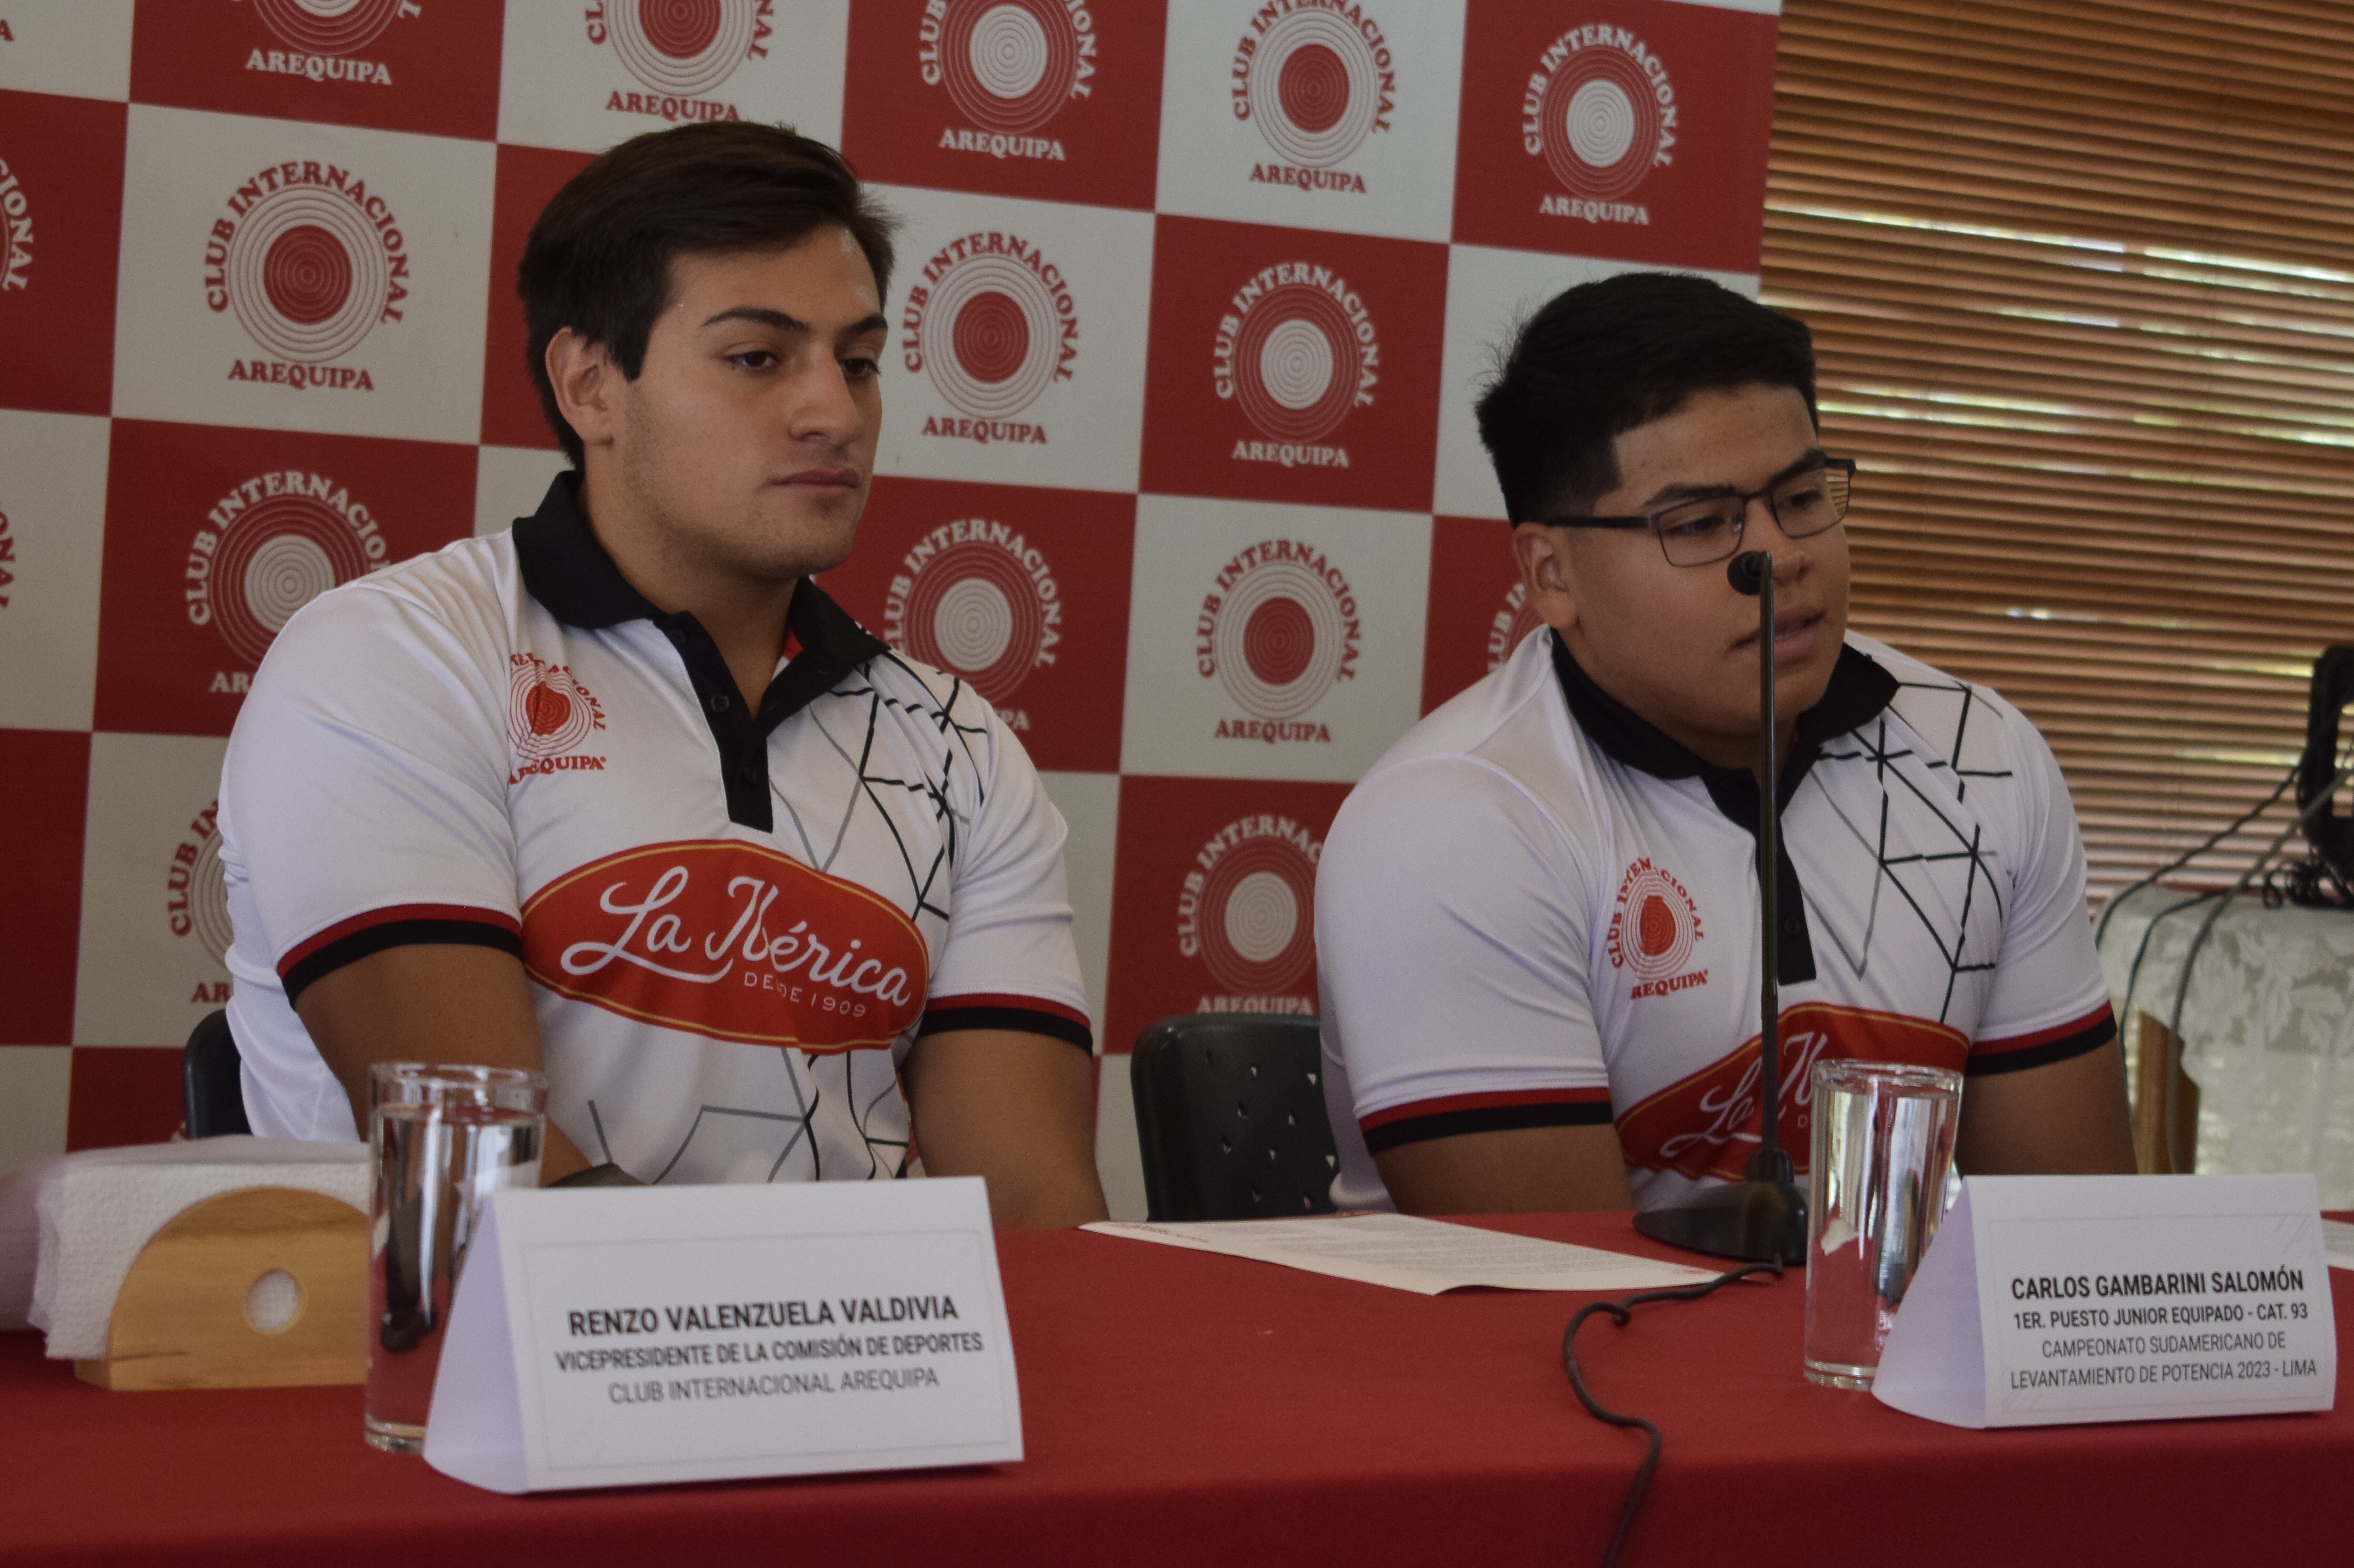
[1521,24,1676,198]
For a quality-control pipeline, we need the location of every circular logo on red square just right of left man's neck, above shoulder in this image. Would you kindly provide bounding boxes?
[883,518,1061,706]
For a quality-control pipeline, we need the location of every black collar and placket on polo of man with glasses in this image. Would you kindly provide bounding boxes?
[1554,631,1897,984]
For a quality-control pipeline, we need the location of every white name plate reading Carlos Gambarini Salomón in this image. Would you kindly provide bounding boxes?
[1872,1175,2338,1427]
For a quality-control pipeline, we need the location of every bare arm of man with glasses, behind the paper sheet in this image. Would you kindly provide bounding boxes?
[1372,1126,1634,1215]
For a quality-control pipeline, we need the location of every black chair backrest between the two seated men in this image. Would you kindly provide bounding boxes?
[1128,1013,1337,1220]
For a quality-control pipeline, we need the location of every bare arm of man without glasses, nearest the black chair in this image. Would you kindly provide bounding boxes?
[902,1029,1111,1229]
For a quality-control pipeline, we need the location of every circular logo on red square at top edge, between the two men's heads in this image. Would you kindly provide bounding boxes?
[916,0,1095,137]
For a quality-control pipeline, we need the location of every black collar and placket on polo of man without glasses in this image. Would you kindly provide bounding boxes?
[515,473,890,833]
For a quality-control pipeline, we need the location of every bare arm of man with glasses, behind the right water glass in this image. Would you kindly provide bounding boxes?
[1954,1040,2135,1175]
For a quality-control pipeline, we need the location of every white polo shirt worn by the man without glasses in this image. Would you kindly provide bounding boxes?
[219,476,1092,1182]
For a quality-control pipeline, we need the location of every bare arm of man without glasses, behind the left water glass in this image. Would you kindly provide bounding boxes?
[294,944,593,1184]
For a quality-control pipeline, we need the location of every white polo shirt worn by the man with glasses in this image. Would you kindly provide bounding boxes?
[1316,628,2114,1208]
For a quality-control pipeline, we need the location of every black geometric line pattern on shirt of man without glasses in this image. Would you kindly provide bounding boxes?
[654,655,989,1182]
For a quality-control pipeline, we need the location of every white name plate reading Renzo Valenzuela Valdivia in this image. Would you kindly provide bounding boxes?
[426,1177,1021,1493]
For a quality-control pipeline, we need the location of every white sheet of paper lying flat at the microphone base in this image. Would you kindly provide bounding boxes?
[1085,1215,1716,1295]
